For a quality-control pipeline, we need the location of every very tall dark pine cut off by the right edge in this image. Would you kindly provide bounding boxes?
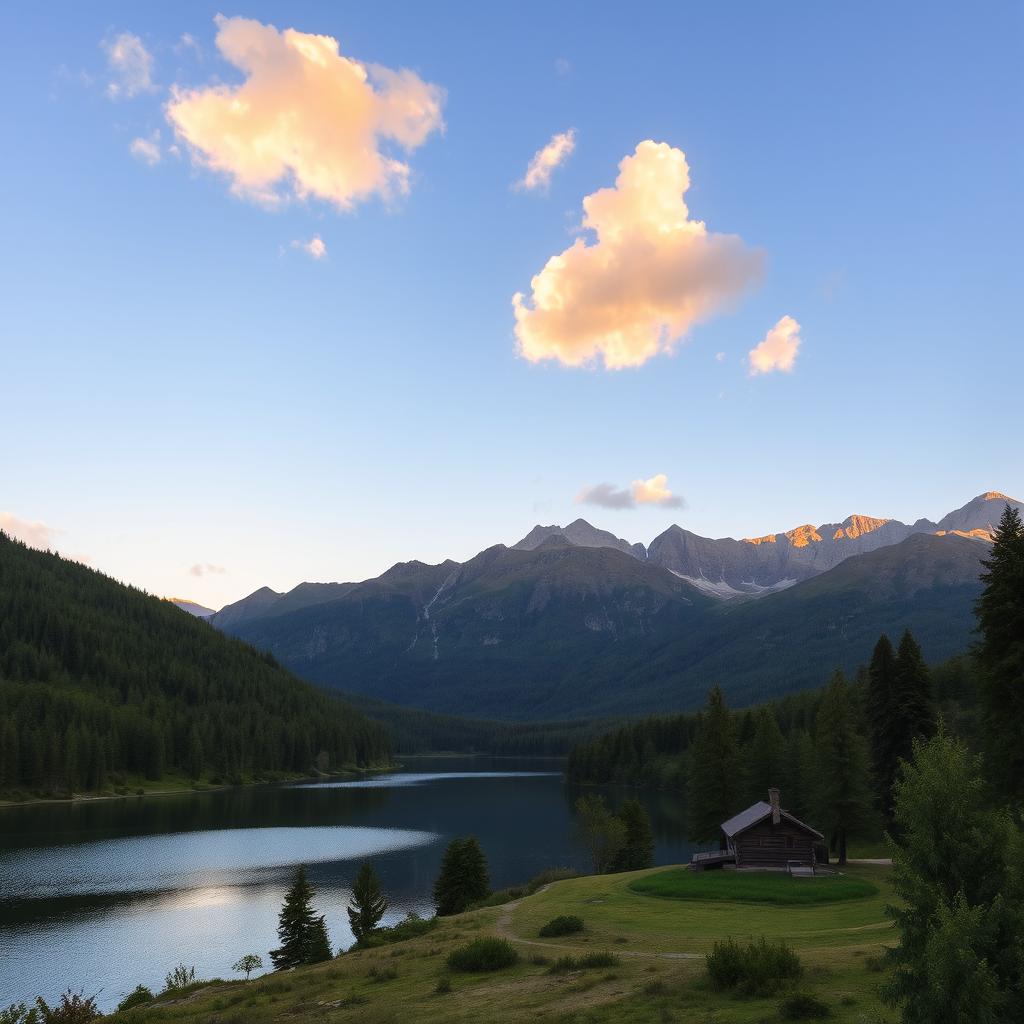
[975,504,1024,802]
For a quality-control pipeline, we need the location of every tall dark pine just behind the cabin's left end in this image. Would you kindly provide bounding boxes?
[687,686,740,843]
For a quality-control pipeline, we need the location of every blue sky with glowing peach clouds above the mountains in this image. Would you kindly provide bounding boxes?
[0,0,1024,607]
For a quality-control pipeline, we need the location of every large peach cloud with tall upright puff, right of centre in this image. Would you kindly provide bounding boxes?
[512,140,762,370]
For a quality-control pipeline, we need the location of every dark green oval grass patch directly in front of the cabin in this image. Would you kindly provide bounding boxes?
[630,867,879,906]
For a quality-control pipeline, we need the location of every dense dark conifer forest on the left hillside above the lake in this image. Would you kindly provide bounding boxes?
[0,532,390,796]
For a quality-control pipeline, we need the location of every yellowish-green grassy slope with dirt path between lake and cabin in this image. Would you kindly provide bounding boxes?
[97,865,895,1024]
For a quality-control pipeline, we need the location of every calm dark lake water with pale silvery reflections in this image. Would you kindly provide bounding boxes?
[0,758,695,1010]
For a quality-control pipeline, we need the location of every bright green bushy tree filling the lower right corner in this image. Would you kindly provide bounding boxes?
[884,732,1024,1024]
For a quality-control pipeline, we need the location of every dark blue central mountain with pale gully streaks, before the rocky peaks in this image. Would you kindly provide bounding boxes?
[228,536,715,719]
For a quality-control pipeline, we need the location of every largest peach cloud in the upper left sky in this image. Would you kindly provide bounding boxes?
[166,14,444,210]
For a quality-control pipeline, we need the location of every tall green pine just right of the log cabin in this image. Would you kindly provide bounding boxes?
[815,672,871,864]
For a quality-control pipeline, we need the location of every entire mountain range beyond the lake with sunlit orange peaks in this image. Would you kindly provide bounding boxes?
[211,492,1021,720]
